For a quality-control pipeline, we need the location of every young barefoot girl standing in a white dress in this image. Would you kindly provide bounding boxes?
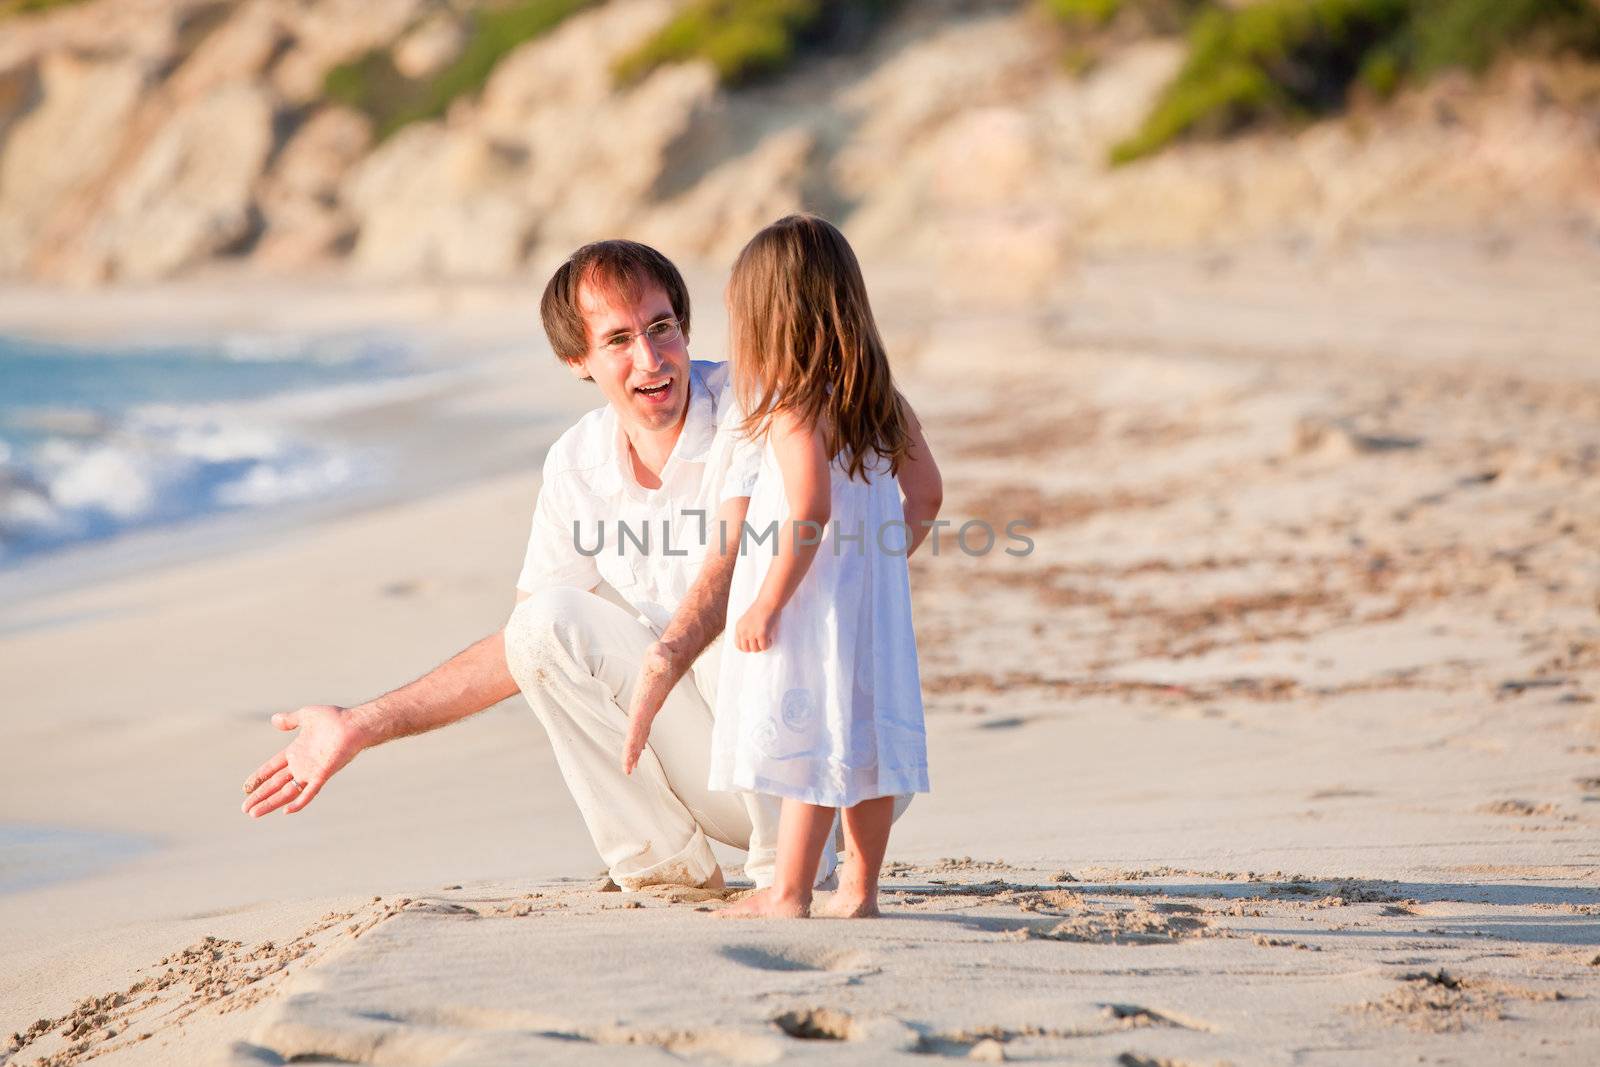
[710,214,941,917]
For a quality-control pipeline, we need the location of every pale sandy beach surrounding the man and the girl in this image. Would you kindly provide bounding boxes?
[0,237,1600,1067]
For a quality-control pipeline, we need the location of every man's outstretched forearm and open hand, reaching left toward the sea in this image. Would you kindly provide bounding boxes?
[243,627,520,819]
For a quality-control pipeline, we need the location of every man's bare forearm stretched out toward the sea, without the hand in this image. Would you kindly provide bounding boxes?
[350,630,518,747]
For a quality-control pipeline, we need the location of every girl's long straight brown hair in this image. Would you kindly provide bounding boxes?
[728,214,910,482]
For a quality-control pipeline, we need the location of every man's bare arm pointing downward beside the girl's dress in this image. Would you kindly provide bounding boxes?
[622,496,750,774]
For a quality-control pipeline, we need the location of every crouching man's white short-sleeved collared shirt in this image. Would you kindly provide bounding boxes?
[517,360,762,633]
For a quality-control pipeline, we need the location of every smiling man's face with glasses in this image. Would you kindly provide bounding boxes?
[568,282,690,430]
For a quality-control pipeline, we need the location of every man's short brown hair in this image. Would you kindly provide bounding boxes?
[539,240,690,363]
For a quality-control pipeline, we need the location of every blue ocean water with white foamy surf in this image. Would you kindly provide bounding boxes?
[0,338,418,571]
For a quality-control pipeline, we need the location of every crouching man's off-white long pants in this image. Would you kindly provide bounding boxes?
[506,589,844,889]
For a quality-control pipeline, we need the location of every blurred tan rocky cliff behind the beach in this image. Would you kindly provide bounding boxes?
[0,0,1600,294]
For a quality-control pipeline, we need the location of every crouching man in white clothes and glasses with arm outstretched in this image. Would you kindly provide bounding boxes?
[243,240,835,889]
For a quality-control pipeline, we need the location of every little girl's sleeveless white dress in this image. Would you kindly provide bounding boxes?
[710,440,928,808]
